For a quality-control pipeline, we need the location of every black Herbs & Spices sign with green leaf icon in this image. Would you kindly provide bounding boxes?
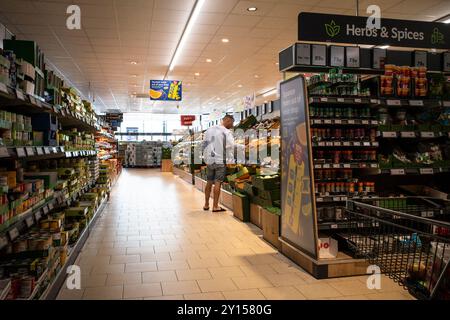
[298,12,450,49]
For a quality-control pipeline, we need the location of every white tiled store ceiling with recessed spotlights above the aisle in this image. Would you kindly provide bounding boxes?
[0,0,450,113]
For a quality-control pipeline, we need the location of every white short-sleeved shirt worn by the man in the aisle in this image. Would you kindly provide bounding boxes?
[203,125,235,164]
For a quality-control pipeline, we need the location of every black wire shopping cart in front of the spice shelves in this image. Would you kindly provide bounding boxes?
[343,197,450,300]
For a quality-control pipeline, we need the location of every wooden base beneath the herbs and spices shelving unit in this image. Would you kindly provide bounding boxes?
[279,237,369,279]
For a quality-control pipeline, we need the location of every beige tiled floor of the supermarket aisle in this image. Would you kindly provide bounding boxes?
[58,169,412,300]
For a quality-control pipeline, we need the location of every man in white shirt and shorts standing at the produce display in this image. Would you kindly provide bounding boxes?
[203,115,234,212]
